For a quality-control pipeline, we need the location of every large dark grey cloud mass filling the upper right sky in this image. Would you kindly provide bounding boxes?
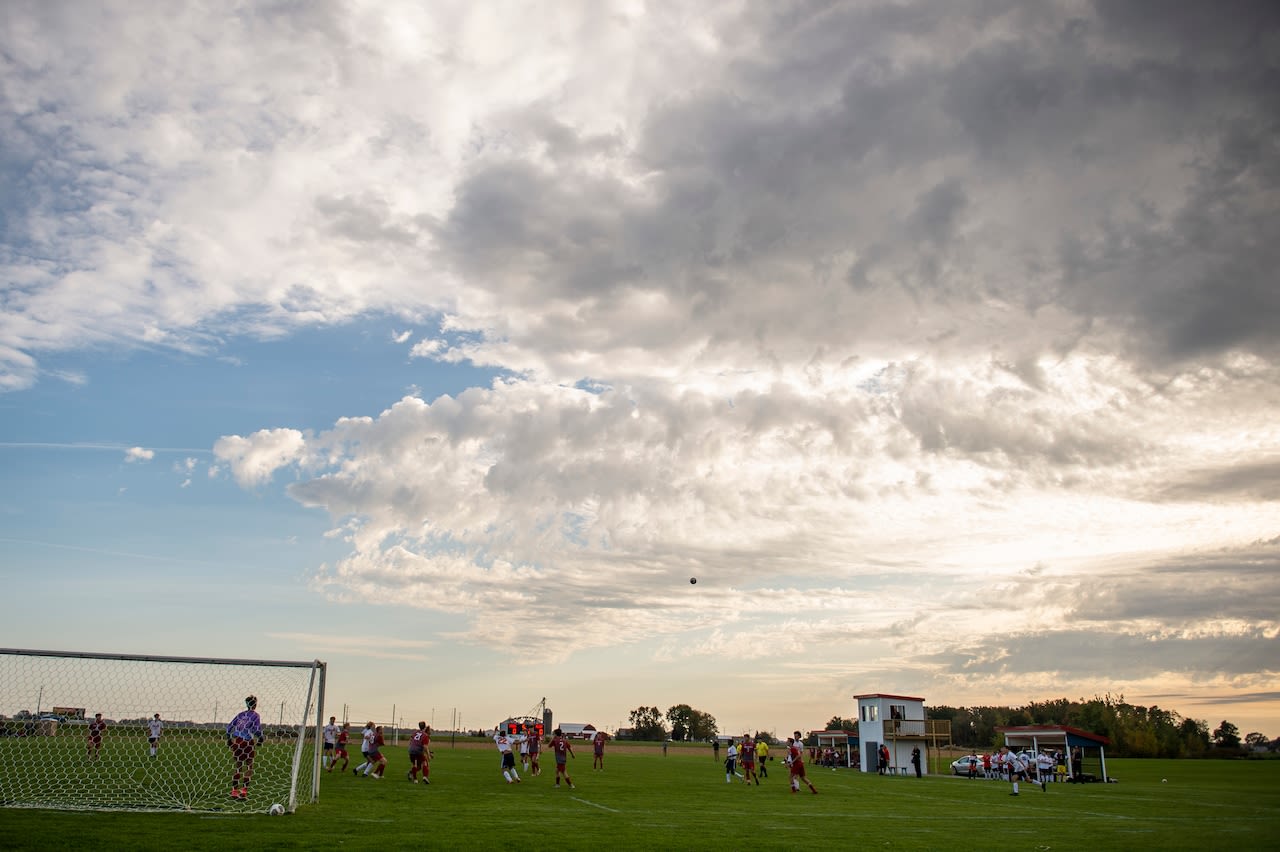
[424,4,1280,370]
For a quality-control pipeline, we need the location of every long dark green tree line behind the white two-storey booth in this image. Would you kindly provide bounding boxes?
[927,695,1268,757]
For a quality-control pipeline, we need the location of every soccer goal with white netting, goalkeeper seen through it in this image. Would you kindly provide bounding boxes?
[0,649,325,812]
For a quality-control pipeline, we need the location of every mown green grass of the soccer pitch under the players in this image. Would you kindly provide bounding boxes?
[0,743,1280,852]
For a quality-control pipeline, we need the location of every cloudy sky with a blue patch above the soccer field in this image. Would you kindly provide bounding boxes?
[0,0,1280,736]
